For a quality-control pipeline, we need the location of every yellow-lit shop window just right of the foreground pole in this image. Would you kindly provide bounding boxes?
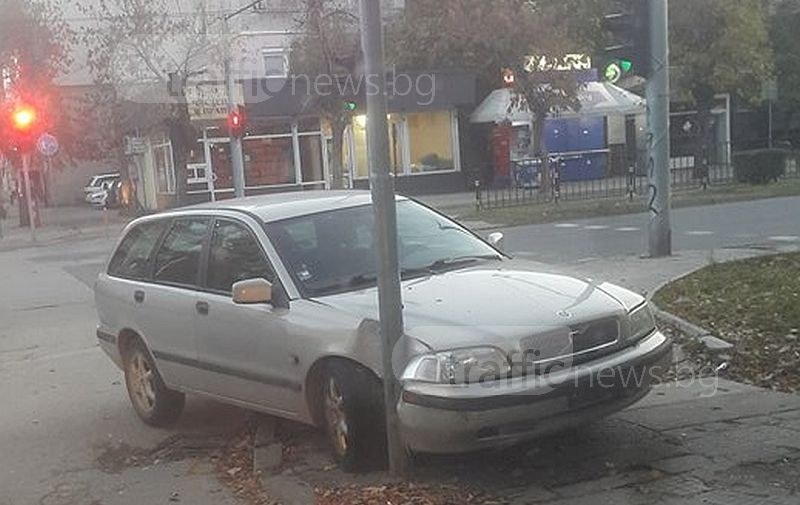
[407,111,454,173]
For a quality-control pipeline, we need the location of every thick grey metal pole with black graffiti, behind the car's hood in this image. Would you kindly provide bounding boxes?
[646,0,672,258]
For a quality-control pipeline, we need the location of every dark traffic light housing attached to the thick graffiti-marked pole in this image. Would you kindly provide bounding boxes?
[602,0,652,83]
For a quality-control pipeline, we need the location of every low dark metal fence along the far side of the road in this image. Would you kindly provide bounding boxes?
[474,153,800,210]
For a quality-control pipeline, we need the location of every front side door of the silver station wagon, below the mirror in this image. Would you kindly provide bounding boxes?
[195,218,302,417]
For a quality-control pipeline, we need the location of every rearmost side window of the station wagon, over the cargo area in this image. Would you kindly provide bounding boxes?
[108,221,165,280]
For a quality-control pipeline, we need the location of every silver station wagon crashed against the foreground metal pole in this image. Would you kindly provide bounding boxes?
[95,191,671,468]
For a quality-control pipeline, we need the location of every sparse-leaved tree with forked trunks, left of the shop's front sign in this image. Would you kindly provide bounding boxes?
[82,0,219,206]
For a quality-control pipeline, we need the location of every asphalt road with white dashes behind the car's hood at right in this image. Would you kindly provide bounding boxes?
[501,197,800,263]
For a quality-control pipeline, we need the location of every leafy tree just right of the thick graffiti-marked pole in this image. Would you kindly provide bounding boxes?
[670,0,773,171]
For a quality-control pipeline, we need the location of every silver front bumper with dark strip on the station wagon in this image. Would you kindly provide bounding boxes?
[398,332,672,453]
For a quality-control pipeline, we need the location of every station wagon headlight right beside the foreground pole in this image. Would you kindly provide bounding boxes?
[403,347,511,384]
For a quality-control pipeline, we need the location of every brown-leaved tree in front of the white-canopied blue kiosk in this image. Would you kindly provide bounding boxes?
[389,0,584,192]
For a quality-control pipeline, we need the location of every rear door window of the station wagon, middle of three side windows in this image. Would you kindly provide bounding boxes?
[153,218,211,286]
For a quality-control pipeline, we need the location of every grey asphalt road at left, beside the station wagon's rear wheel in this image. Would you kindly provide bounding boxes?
[0,234,245,505]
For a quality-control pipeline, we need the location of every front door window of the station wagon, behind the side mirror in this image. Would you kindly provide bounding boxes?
[206,219,275,293]
